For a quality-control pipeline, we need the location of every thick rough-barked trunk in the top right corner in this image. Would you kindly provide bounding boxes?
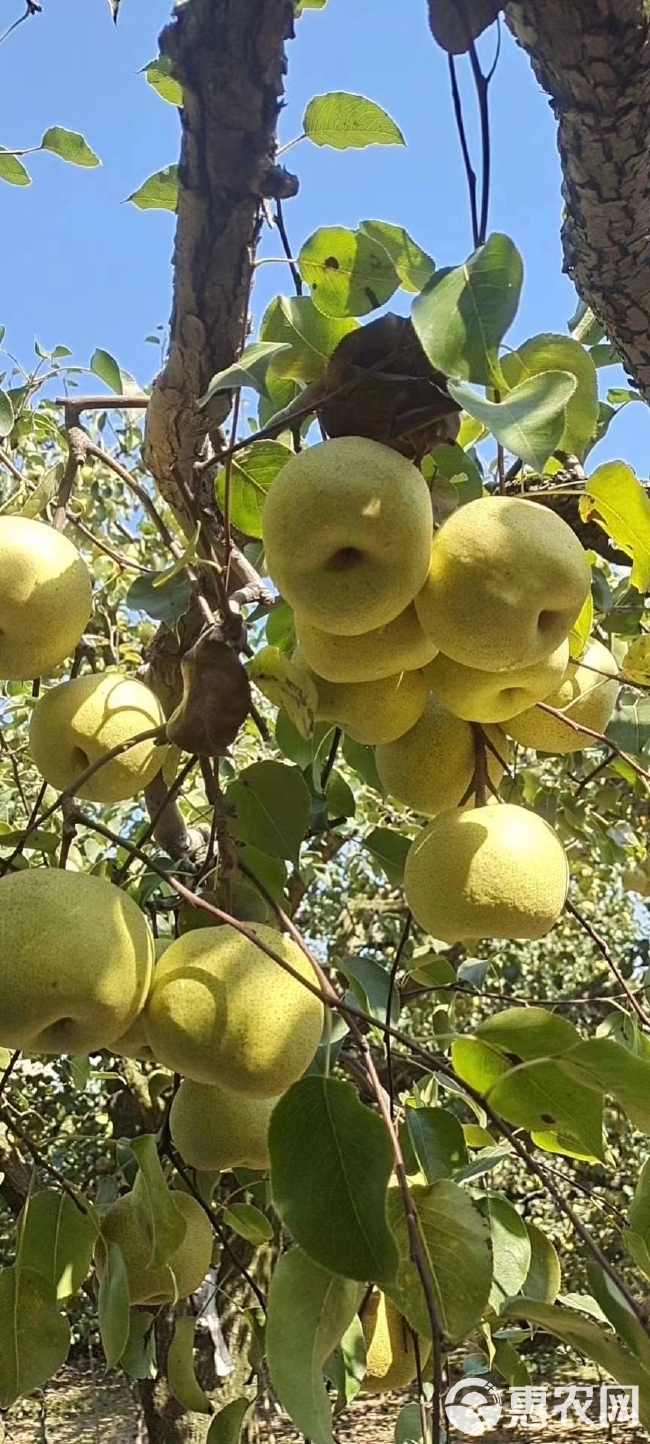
[504,0,650,400]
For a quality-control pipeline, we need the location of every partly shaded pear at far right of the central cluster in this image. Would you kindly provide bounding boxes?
[506,638,618,752]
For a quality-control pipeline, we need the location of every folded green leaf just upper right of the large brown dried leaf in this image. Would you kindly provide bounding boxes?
[412,232,523,386]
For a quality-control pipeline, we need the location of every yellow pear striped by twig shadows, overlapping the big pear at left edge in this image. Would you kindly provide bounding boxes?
[144,923,324,1099]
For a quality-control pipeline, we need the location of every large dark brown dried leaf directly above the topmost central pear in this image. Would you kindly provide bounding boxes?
[318,312,459,461]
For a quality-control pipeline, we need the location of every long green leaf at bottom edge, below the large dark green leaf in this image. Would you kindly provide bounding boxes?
[266,1249,360,1444]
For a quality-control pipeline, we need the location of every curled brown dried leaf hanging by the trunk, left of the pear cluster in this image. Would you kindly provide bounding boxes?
[168,628,250,757]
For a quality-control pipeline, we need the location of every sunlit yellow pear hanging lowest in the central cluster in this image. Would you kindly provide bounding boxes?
[404,803,569,943]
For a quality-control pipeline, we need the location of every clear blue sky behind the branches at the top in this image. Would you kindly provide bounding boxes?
[0,0,650,477]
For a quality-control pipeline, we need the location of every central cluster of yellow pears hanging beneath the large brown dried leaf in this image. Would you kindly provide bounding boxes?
[263,438,618,944]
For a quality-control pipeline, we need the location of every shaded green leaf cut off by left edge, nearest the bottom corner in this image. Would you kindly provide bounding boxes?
[0,1268,69,1409]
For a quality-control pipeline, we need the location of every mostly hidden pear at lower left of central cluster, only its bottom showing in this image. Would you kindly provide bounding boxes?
[315,671,429,747]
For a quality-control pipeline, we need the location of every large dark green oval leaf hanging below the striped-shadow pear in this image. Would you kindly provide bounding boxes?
[269,1076,397,1282]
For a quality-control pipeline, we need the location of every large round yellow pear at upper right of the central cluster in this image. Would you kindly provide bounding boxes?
[416,497,591,671]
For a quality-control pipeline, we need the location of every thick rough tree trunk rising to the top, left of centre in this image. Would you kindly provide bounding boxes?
[144,0,298,536]
